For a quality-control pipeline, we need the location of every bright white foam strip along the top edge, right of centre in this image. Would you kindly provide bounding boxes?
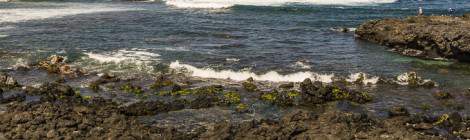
[166,0,397,8]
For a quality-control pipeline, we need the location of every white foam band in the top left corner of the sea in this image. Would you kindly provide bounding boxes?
[0,3,139,23]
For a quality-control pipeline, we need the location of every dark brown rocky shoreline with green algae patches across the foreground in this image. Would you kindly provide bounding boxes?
[0,56,470,139]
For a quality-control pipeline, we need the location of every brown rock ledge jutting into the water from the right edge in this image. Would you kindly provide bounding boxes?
[355,14,470,62]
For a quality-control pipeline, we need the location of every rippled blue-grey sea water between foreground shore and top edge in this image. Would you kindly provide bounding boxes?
[0,0,470,88]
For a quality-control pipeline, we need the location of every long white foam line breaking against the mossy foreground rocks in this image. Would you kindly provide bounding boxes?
[170,61,334,83]
